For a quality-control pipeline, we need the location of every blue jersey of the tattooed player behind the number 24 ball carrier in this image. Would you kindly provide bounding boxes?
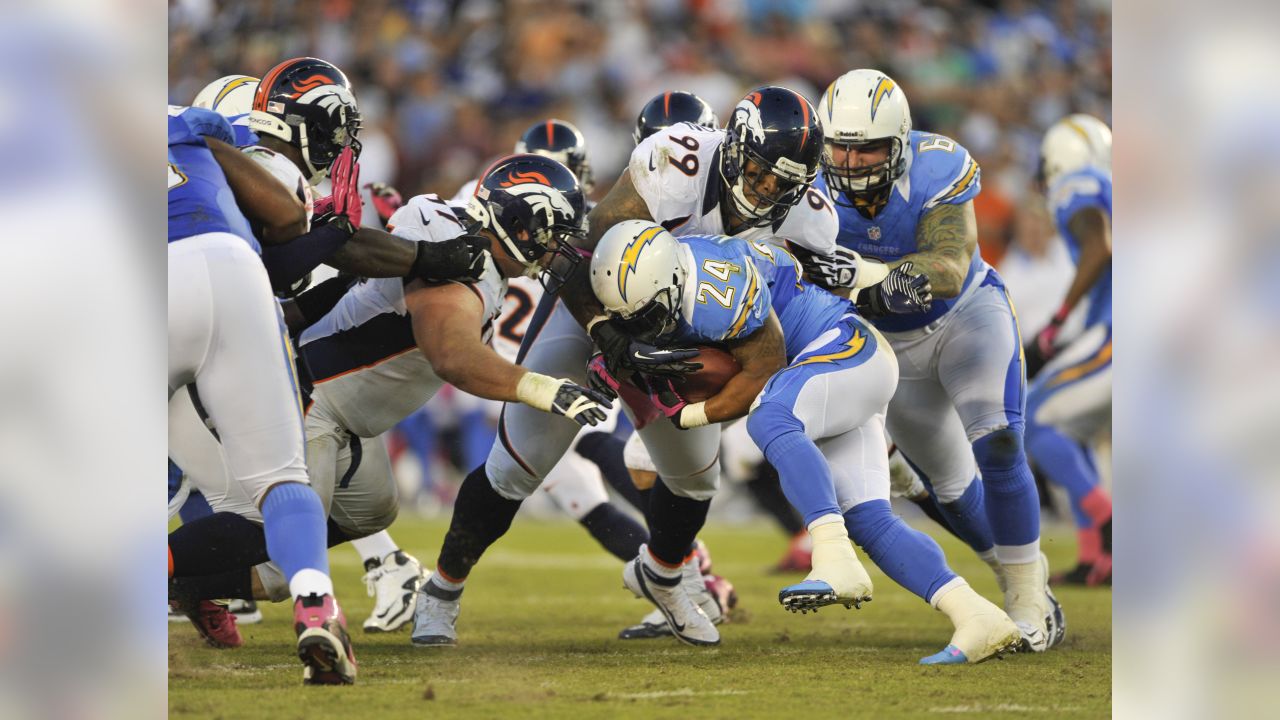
[813,131,989,332]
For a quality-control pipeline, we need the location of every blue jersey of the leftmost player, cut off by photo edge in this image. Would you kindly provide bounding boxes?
[169,106,262,252]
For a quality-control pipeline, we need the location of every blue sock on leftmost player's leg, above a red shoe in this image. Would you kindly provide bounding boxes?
[262,483,329,579]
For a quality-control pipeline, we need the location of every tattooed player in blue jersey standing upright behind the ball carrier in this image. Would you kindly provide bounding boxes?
[815,69,1061,652]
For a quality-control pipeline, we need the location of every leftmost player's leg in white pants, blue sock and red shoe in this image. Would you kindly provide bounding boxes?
[170,240,356,684]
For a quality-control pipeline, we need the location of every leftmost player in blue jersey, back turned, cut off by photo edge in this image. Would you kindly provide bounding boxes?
[168,108,356,684]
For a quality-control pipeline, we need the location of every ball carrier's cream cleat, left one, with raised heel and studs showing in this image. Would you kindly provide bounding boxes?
[778,515,872,612]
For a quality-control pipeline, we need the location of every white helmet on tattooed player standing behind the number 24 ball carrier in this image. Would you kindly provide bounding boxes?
[818,69,911,200]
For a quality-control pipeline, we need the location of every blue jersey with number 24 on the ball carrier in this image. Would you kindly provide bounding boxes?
[672,236,852,361]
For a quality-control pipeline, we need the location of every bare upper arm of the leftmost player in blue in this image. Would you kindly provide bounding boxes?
[205,137,307,245]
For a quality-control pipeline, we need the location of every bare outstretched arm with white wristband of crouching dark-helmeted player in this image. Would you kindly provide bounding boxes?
[404,281,609,425]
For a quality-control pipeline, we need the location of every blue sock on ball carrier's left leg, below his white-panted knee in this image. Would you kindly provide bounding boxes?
[746,402,840,527]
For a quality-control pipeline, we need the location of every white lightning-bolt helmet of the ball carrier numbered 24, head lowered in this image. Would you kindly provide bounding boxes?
[591,220,689,340]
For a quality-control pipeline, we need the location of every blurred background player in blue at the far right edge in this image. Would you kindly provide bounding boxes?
[1025,114,1111,585]
